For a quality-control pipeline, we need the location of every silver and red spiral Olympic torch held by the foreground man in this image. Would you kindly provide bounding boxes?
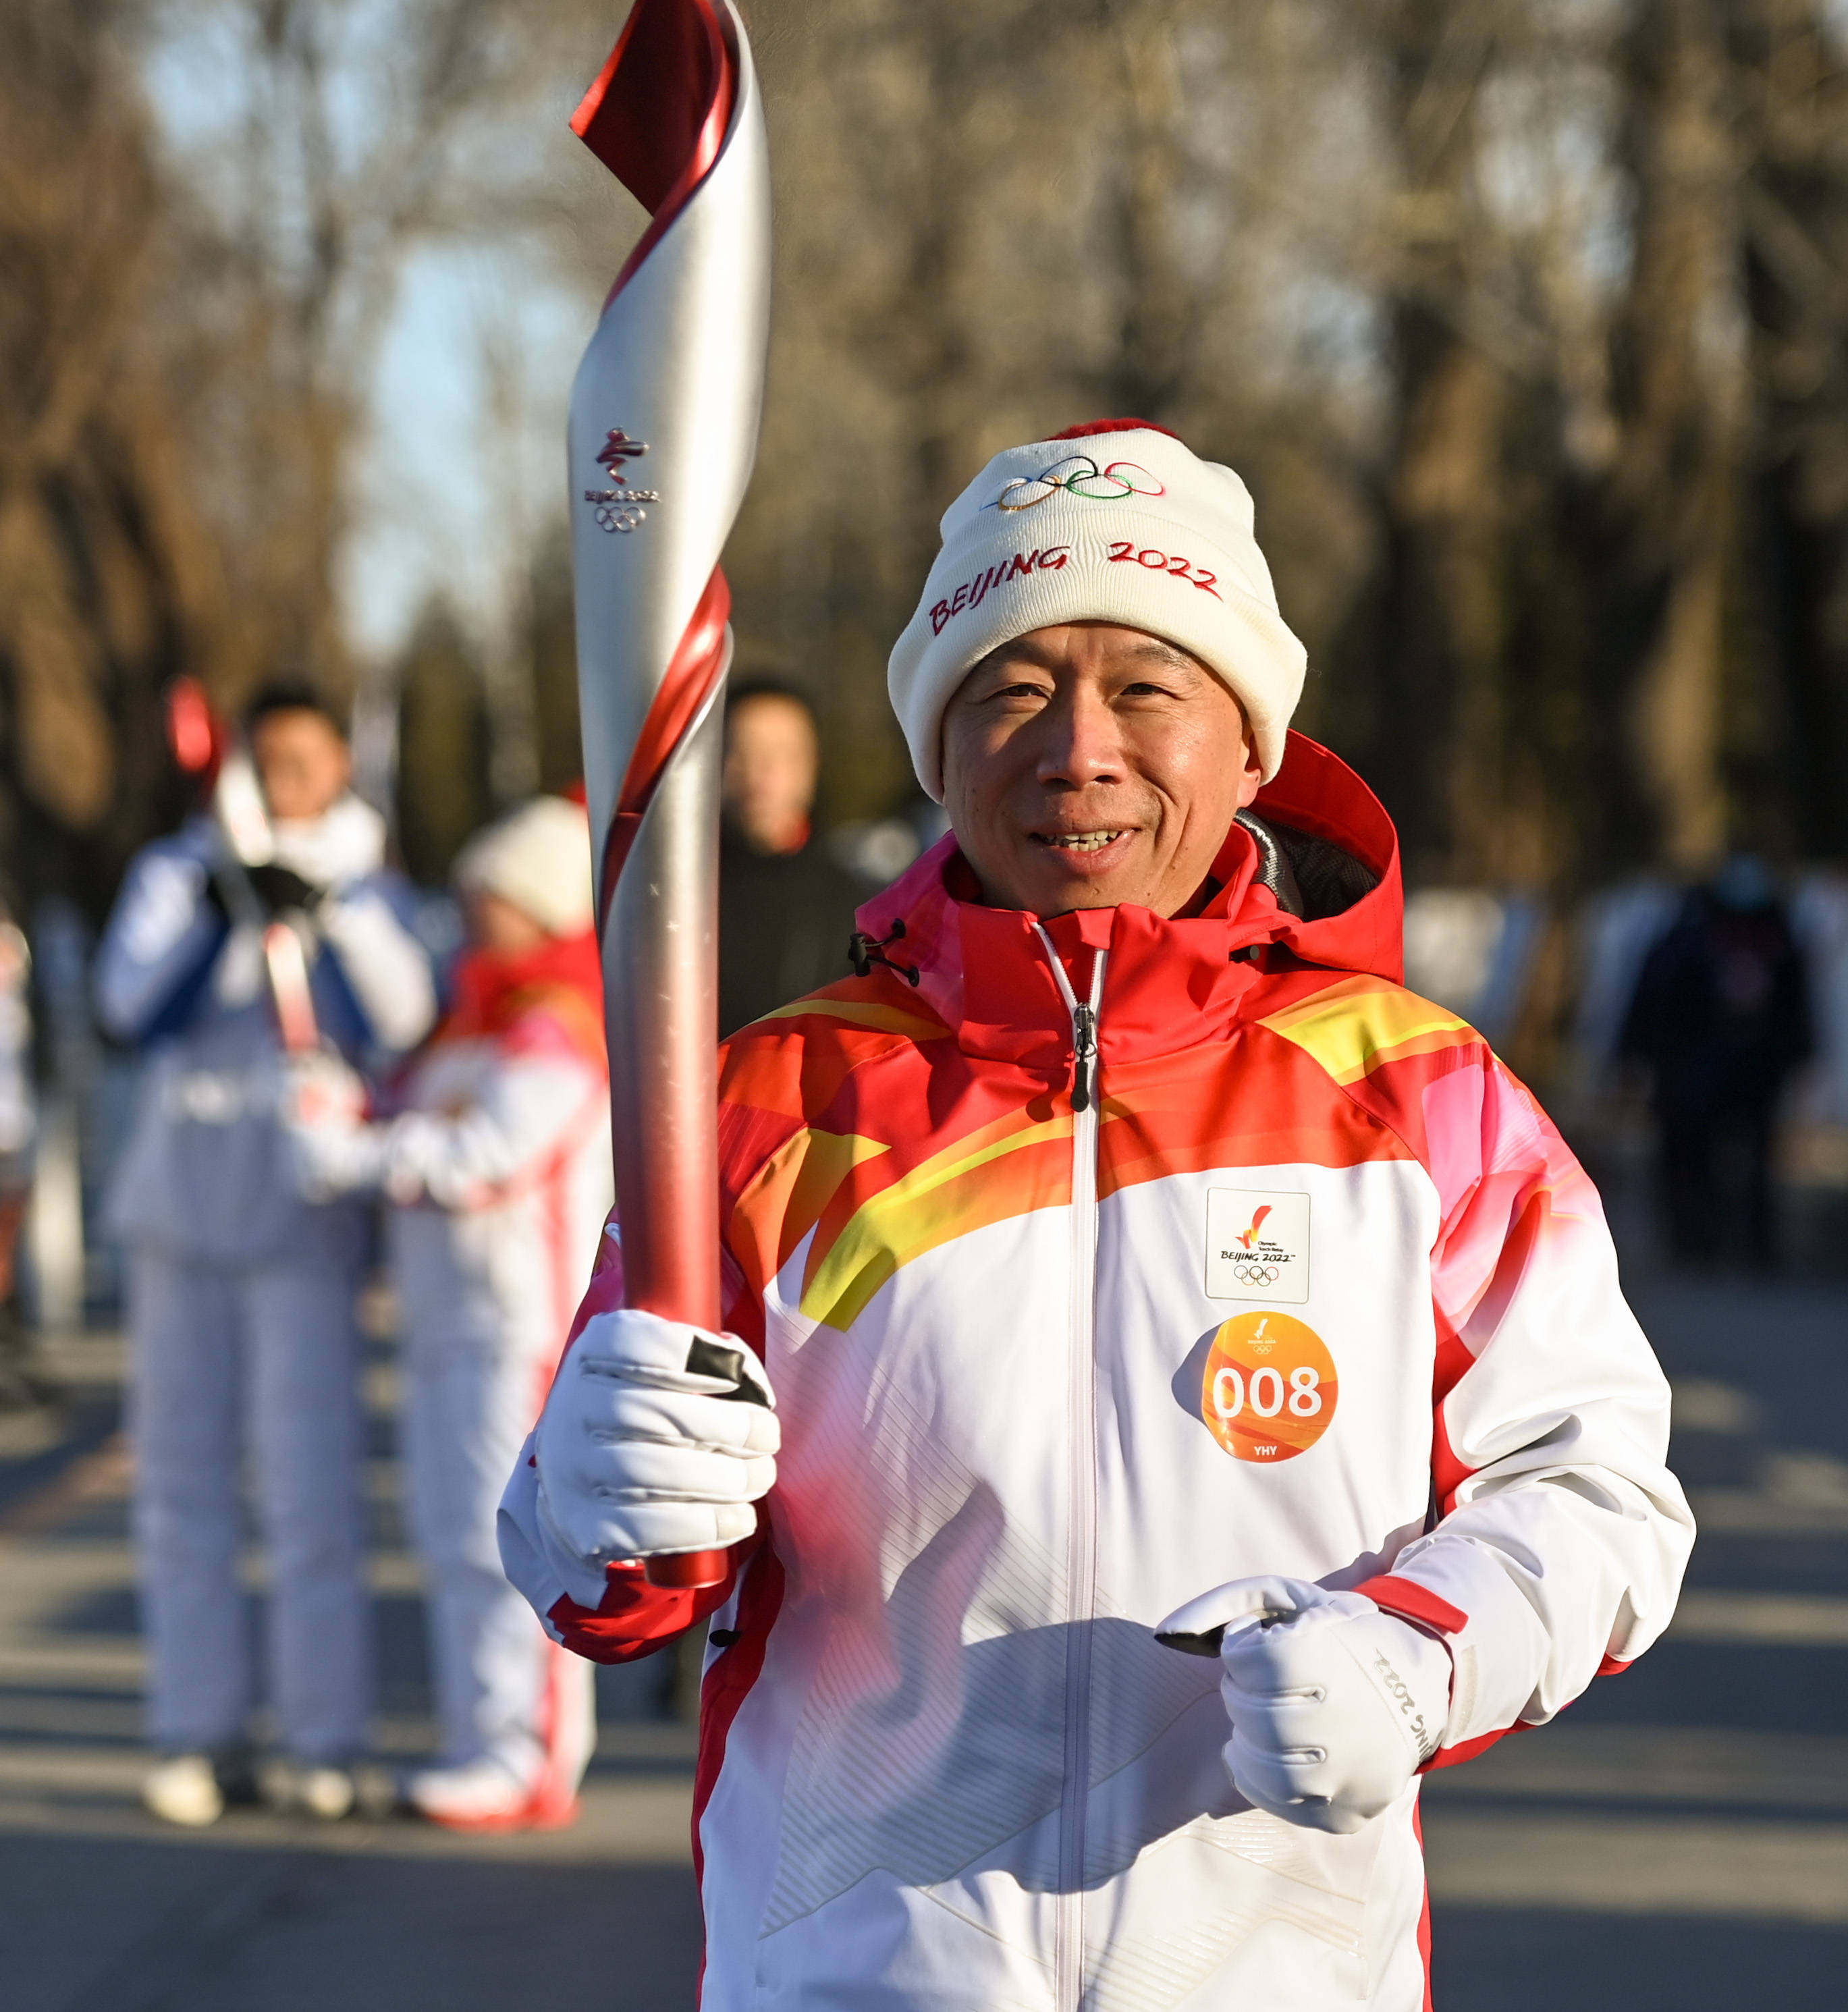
[570,0,771,1585]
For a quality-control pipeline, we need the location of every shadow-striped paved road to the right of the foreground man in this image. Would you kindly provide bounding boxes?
[1425,1280,1848,2012]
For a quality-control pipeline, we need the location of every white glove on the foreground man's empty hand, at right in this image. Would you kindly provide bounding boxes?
[1156,1579,1451,1833]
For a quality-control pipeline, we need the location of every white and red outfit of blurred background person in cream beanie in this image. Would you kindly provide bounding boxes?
[312,929,612,1829]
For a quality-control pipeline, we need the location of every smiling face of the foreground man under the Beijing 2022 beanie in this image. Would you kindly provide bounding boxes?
[944,622,1262,915]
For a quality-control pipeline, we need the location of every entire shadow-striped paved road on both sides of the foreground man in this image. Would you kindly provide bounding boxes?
[0,1280,1848,2012]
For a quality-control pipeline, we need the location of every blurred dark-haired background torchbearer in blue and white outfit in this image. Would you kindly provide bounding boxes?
[94,686,435,1823]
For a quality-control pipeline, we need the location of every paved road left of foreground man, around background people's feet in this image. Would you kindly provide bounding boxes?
[0,1340,699,2012]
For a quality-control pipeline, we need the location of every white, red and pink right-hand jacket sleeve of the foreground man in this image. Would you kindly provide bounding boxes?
[1363,1046,1693,1766]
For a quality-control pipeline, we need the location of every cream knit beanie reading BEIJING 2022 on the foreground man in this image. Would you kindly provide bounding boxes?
[886,418,1307,803]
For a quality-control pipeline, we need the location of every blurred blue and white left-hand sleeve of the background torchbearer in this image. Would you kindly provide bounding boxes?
[94,829,227,1042]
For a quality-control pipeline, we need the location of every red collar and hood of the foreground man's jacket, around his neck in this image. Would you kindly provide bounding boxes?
[856,732,1405,1066]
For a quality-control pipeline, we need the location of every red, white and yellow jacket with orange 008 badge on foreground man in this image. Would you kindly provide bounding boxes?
[501,736,1693,2012]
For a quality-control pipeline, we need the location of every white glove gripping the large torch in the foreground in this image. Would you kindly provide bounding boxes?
[533,1308,783,1604]
